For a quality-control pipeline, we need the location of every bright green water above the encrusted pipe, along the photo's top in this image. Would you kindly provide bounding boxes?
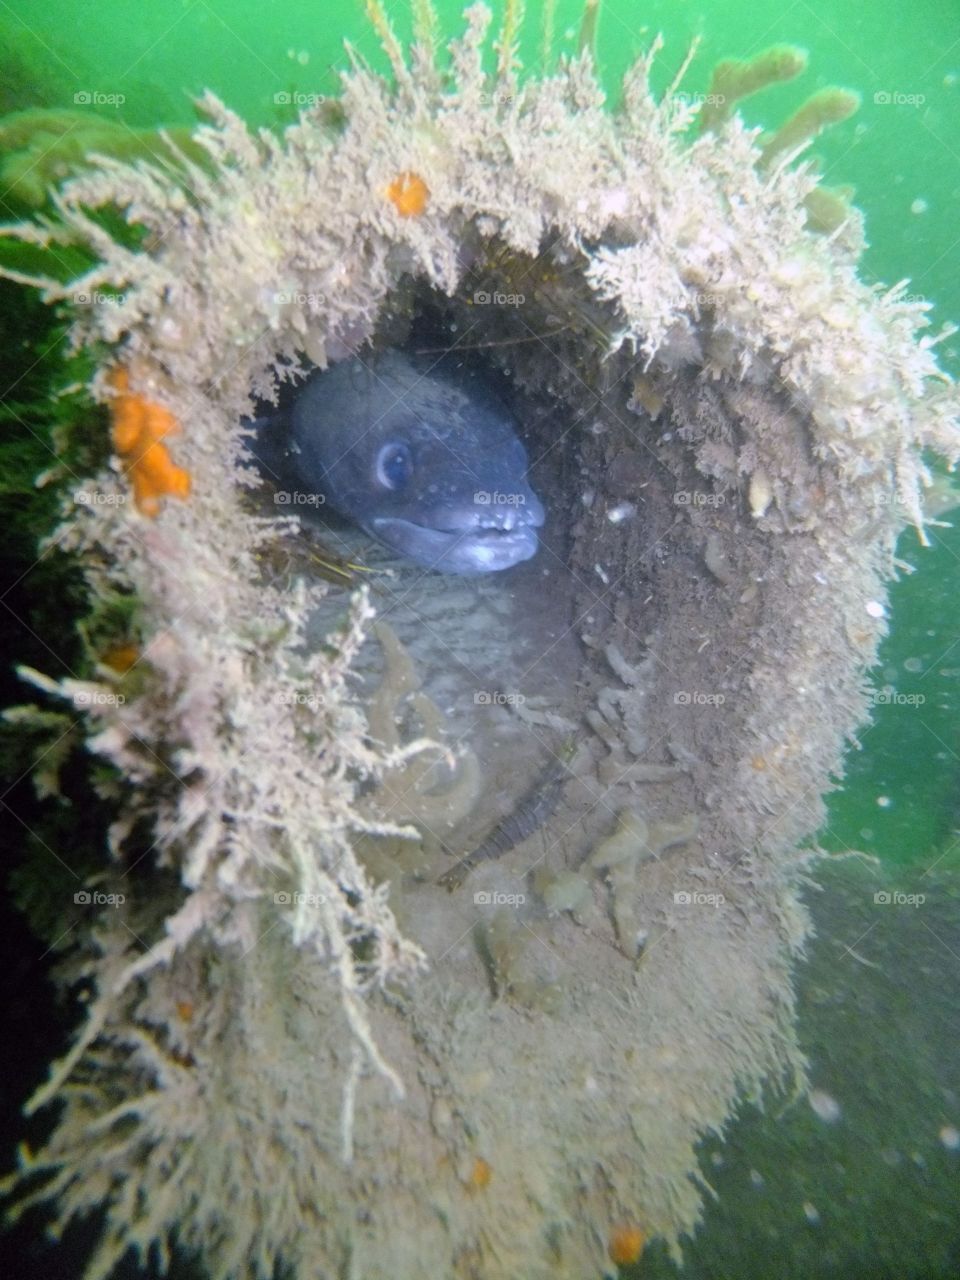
[7,0,960,335]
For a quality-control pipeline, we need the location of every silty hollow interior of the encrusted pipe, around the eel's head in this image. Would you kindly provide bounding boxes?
[240,252,813,977]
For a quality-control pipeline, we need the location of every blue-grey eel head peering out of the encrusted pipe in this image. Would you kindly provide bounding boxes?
[292,351,544,573]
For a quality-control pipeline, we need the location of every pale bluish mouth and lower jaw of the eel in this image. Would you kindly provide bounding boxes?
[370,516,539,573]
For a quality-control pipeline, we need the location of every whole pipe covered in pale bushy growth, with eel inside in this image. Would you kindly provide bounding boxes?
[3,4,957,1280]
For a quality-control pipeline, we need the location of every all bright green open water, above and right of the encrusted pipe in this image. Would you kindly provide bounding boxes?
[0,0,960,869]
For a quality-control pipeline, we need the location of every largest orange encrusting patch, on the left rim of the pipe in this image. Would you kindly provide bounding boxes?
[109,367,189,518]
